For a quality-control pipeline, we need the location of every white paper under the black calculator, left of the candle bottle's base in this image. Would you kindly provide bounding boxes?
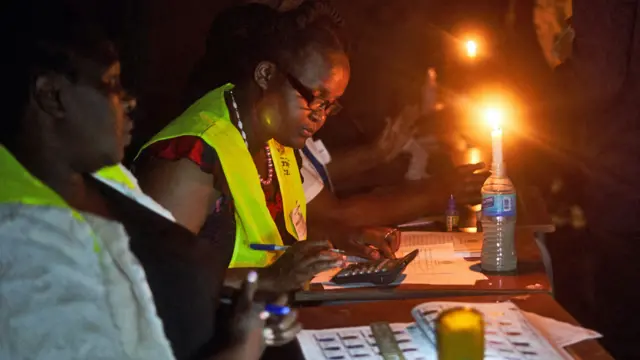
[312,242,487,290]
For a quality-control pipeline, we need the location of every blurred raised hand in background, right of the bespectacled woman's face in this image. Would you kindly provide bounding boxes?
[375,106,420,162]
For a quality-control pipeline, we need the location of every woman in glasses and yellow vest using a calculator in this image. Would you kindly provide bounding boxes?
[135,1,350,291]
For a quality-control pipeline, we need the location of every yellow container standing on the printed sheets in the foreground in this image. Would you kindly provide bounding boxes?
[436,308,484,360]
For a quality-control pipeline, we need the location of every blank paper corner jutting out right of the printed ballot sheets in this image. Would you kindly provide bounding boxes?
[522,311,602,347]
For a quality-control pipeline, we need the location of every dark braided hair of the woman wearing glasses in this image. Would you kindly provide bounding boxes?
[185,0,347,105]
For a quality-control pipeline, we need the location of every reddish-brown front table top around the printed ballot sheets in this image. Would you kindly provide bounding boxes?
[263,294,613,360]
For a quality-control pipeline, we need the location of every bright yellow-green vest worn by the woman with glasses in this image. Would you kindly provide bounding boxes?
[138,84,306,267]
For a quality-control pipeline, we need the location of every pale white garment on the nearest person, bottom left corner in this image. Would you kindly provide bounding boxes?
[0,167,174,360]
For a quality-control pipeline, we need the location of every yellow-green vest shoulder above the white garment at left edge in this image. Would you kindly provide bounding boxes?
[0,145,100,253]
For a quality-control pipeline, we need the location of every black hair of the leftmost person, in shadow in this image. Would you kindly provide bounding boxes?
[0,0,112,149]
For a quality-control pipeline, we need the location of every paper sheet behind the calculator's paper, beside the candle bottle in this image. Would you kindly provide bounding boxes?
[400,231,482,257]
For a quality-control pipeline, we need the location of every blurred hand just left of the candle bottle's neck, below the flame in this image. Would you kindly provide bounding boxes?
[443,163,490,205]
